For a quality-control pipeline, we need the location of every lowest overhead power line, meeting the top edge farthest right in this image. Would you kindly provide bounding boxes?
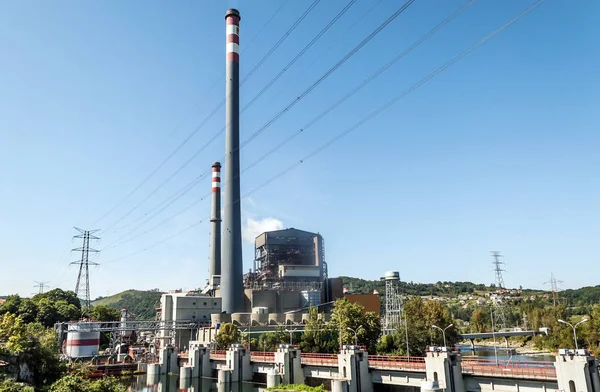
[102,0,545,263]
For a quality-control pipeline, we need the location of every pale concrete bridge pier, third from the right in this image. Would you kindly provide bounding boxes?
[338,346,373,392]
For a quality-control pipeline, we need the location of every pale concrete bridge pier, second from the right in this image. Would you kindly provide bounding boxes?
[425,347,465,392]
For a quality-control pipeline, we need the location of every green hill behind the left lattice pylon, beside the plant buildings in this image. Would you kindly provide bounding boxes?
[92,290,163,320]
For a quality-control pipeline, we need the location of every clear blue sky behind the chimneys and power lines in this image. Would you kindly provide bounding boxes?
[0,0,600,297]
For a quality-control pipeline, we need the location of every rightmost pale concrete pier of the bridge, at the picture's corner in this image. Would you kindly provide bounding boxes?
[555,349,600,392]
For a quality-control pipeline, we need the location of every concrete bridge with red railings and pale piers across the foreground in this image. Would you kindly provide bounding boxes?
[147,344,600,392]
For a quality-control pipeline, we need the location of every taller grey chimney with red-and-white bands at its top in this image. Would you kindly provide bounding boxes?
[221,9,244,313]
